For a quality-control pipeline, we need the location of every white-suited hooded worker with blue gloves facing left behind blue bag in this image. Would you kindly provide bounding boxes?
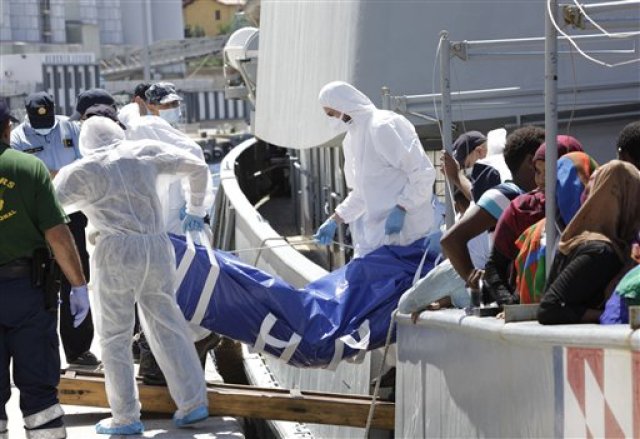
[314,81,436,257]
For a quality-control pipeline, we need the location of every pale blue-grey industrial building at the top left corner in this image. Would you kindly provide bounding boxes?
[0,0,184,58]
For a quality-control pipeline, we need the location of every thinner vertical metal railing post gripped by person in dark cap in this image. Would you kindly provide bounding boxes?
[440,30,455,229]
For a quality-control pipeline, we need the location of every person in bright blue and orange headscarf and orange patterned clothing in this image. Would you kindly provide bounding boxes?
[515,152,598,303]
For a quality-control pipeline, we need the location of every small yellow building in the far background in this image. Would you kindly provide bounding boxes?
[182,0,246,38]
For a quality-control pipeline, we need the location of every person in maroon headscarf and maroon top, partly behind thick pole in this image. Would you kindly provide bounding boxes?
[484,136,583,305]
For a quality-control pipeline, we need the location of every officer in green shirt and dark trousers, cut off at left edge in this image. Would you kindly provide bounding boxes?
[0,97,89,439]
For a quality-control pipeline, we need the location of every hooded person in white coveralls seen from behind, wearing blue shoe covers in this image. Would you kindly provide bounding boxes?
[54,116,209,434]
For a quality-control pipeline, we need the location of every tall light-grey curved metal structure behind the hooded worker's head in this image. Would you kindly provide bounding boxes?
[255,0,360,147]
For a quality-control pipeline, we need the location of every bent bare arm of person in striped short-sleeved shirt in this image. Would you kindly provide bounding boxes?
[440,206,496,281]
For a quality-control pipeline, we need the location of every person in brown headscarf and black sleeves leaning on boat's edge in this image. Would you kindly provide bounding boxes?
[538,160,640,325]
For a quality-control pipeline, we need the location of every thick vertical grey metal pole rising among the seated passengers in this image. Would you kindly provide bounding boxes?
[544,0,558,277]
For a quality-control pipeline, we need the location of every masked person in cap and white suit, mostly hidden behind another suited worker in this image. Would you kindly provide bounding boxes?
[125,82,213,235]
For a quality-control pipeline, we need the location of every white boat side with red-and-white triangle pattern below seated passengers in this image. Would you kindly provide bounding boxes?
[395,310,640,439]
